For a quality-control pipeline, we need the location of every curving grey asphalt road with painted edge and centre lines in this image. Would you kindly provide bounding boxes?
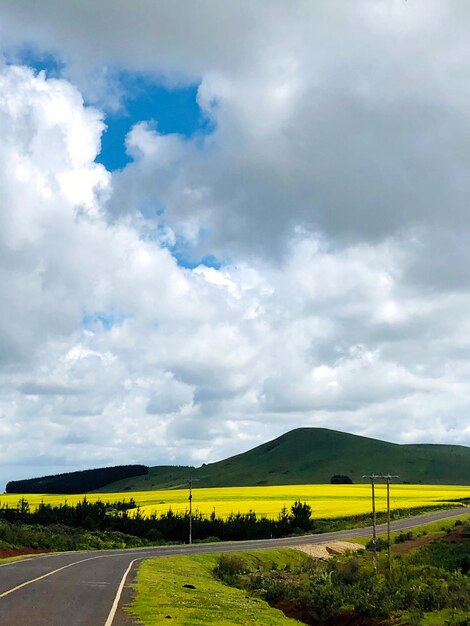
[0,508,469,626]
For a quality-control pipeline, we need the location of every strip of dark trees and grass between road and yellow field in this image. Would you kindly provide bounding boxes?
[0,498,313,550]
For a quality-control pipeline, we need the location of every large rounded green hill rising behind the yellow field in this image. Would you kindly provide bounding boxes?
[95,428,470,492]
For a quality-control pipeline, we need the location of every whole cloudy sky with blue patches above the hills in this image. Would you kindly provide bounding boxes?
[0,0,470,488]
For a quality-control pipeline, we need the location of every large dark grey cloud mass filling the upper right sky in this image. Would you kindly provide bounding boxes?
[2,0,470,256]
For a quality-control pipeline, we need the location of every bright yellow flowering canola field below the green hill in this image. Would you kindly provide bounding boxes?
[0,484,470,518]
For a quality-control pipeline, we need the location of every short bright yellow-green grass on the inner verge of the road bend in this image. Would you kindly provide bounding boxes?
[128,548,309,626]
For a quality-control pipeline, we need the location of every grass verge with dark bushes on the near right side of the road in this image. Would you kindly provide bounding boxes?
[128,521,470,626]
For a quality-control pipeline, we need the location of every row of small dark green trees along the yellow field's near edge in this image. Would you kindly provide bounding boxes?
[0,498,313,543]
